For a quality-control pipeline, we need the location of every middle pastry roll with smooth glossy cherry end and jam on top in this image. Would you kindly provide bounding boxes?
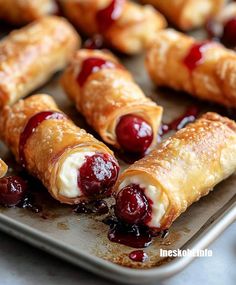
[62,49,162,154]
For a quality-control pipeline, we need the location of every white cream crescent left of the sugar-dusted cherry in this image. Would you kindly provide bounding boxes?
[57,152,95,198]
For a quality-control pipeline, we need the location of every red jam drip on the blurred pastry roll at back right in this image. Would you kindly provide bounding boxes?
[183,42,209,71]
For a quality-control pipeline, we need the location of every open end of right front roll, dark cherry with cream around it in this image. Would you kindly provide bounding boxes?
[115,173,169,229]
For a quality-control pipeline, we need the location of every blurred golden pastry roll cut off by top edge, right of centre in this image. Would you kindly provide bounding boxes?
[142,0,225,31]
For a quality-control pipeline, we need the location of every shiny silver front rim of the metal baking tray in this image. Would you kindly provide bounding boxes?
[0,194,236,284]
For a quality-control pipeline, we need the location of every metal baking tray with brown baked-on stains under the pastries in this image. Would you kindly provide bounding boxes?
[0,23,236,284]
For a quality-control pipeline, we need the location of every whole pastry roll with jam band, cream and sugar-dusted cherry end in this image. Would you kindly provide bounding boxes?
[0,95,119,204]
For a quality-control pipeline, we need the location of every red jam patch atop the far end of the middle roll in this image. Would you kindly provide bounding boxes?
[77,57,117,87]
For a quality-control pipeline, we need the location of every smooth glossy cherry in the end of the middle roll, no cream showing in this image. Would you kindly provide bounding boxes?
[116,115,153,154]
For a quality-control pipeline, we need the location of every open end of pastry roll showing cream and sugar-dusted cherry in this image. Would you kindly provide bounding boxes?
[54,148,119,203]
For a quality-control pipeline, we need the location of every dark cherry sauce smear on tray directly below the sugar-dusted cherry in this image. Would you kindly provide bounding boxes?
[73,200,109,215]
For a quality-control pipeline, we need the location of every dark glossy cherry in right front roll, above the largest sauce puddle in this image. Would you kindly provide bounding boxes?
[115,184,151,224]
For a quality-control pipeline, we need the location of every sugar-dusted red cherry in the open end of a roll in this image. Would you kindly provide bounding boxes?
[78,153,119,196]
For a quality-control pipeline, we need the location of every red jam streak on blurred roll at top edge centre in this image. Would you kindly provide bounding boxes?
[96,0,125,33]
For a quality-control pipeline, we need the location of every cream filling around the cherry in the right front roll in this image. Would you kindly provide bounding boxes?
[119,175,168,228]
